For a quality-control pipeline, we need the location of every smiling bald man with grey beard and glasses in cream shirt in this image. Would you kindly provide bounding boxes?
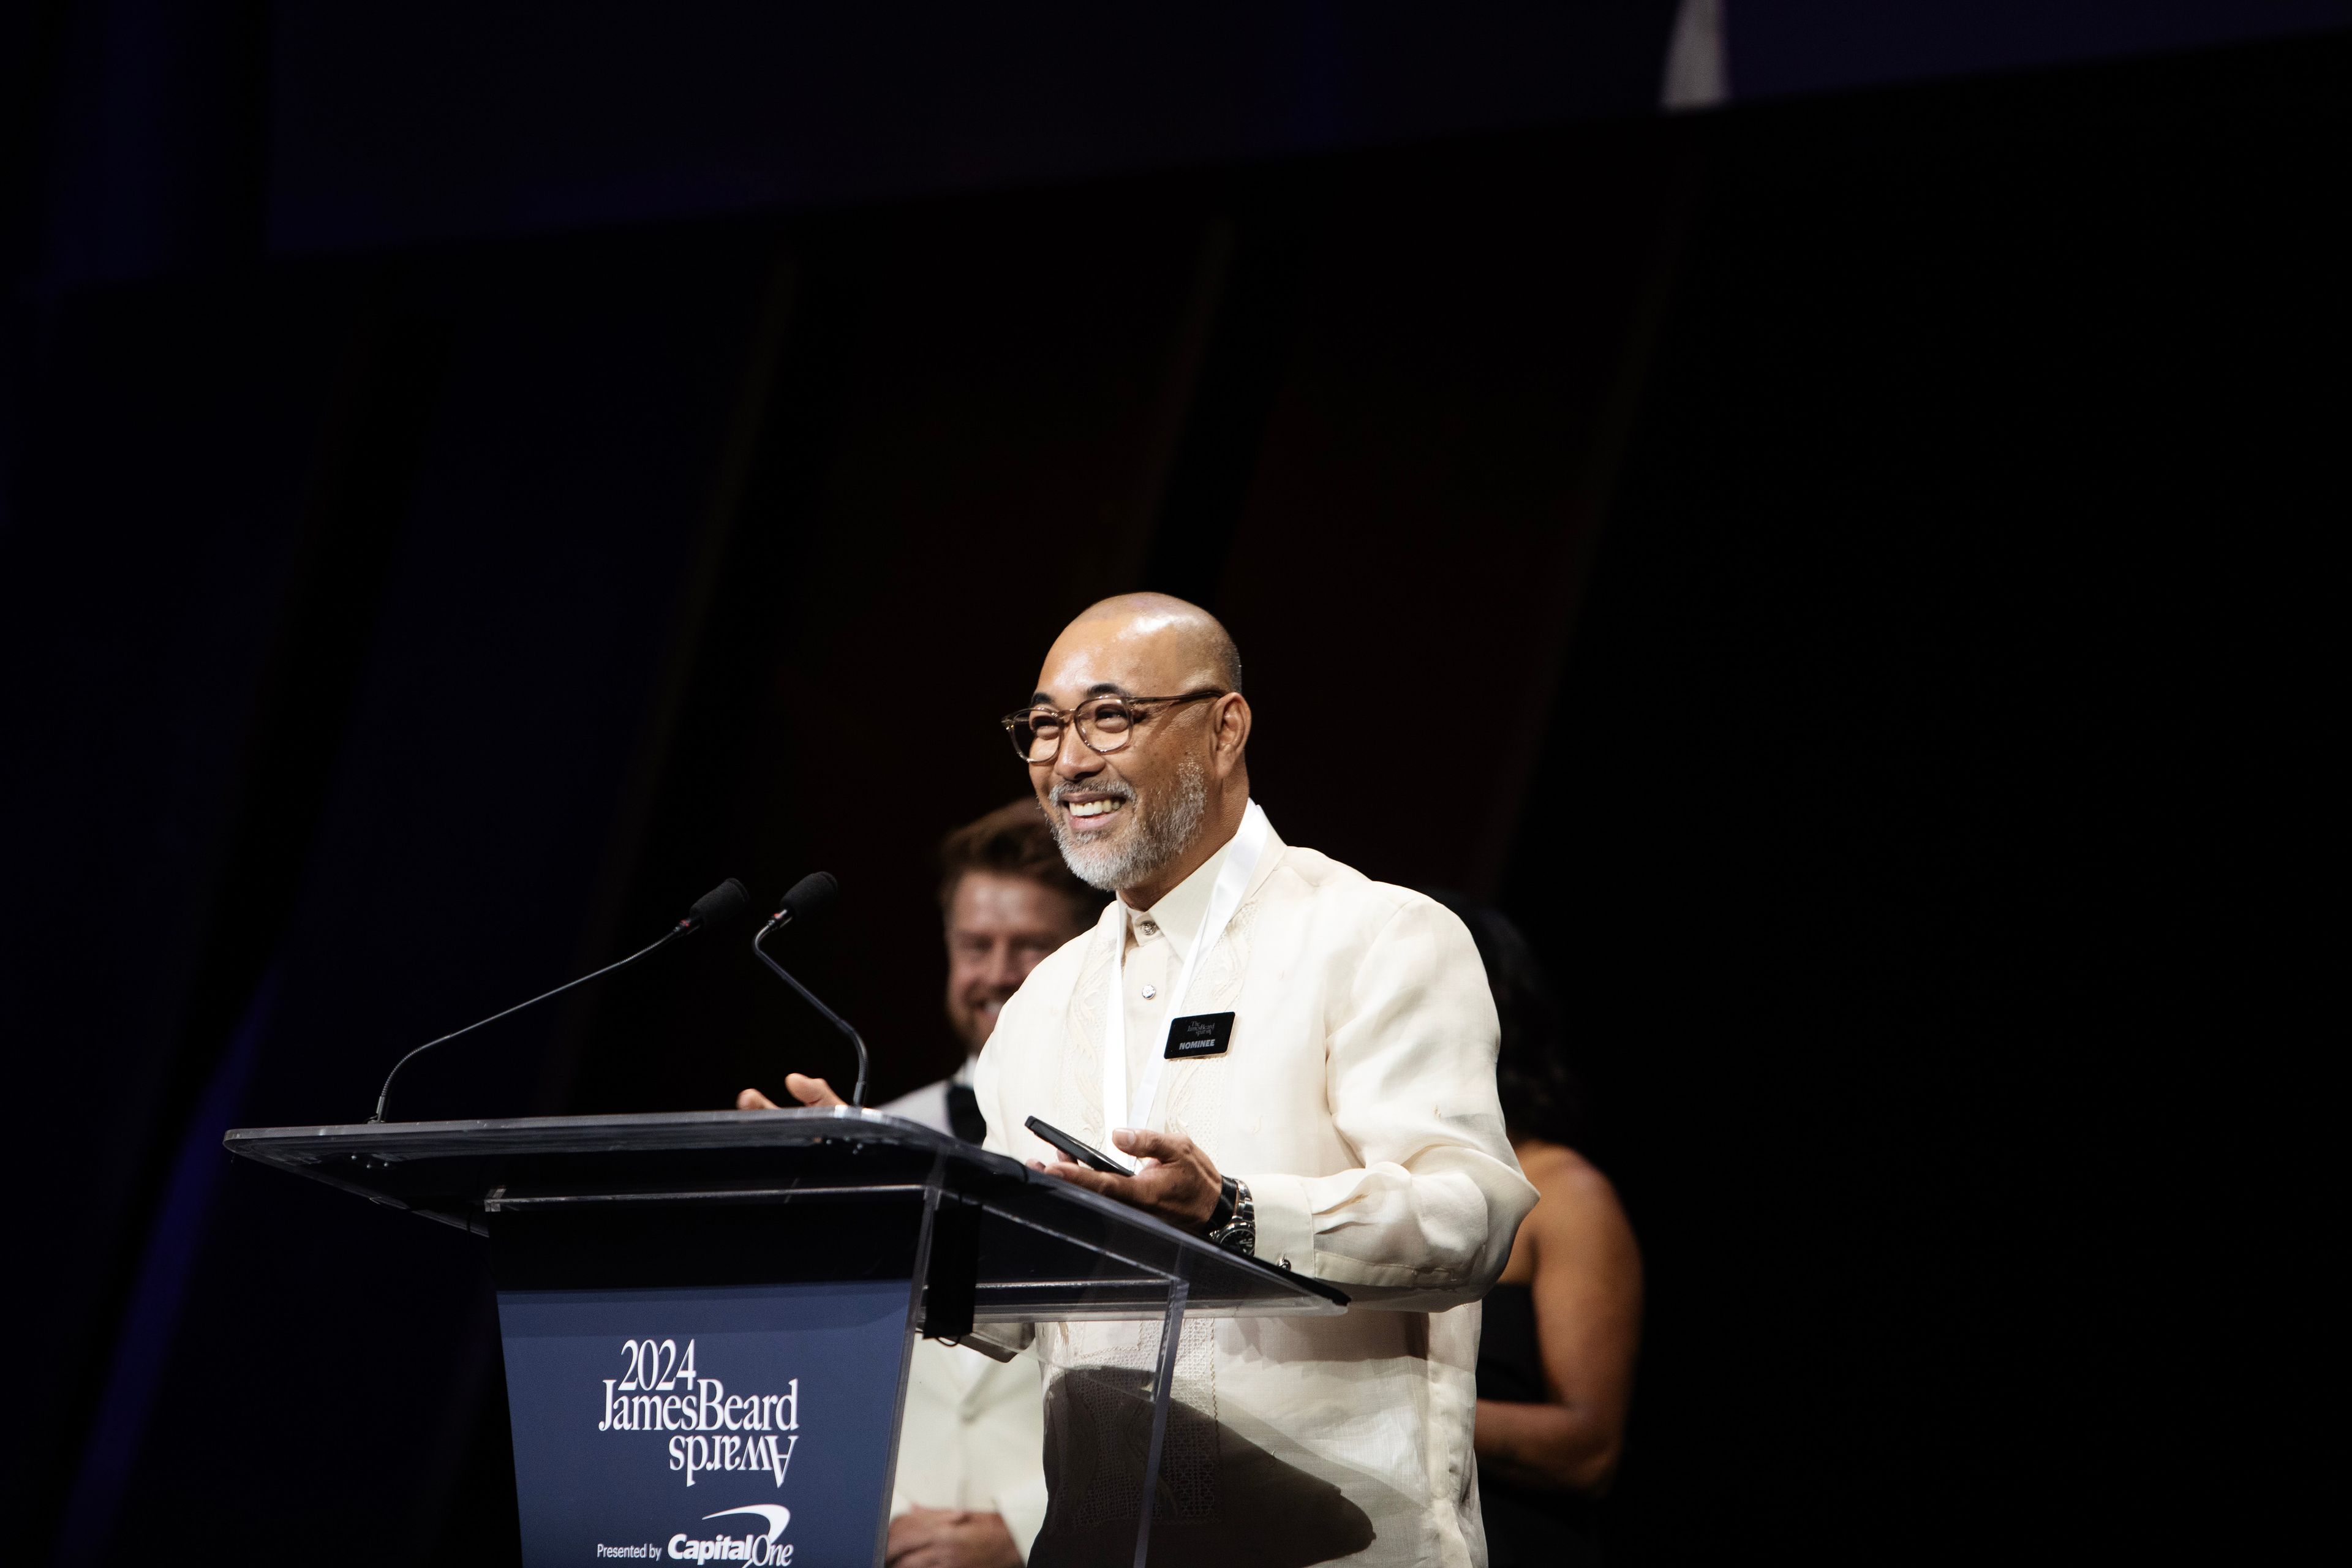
[743,595,1536,1568]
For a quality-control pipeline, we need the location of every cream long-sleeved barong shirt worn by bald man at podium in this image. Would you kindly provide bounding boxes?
[974,806,1536,1568]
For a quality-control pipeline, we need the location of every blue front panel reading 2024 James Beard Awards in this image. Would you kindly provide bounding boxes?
[499,1279,908,1568]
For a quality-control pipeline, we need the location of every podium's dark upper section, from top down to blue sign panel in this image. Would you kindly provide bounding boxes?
[234,1107,1348,1338]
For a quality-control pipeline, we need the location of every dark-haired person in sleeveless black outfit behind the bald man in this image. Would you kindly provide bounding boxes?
[1434,893,1642,1568]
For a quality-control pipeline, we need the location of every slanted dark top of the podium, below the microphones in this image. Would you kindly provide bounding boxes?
[221,1107,1348,1324]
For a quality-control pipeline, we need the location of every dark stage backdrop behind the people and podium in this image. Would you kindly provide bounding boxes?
[0,5,2352,1563]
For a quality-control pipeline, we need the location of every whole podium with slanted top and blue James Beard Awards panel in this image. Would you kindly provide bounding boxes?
[224,1107,1348,1568]
